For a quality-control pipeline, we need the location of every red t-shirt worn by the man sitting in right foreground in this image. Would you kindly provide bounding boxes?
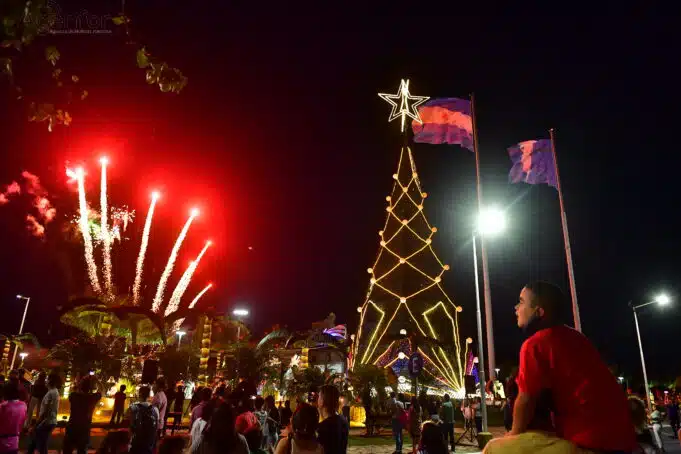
[517,326,636,451]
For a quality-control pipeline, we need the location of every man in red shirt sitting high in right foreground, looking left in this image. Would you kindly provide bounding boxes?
[485,282,636,453]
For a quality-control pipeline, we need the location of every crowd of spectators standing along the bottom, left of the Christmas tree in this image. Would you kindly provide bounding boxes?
[0,371,349,454]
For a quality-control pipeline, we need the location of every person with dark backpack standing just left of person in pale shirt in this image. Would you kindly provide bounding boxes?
[127,386,161,454]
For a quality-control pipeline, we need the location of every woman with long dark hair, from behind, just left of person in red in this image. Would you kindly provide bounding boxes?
[196,403,249,454]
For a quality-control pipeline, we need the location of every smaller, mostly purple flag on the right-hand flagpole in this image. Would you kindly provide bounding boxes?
[508,139,558,188]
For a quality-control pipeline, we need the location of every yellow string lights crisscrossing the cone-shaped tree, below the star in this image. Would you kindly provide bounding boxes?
[351,148,468,391]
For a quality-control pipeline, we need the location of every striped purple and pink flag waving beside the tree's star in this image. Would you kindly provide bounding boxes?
[411,98,474,151]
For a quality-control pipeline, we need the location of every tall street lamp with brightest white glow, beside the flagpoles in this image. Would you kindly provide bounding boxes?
[473,209,505,432]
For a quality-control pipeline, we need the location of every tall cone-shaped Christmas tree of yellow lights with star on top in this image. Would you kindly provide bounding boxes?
[351,81,469,391]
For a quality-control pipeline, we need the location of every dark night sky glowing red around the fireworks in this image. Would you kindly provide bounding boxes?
[0,8,681,380]
